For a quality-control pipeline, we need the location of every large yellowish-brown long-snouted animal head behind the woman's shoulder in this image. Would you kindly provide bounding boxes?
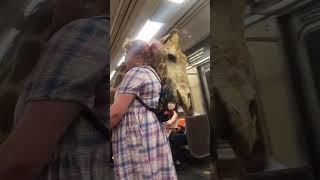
[110,30,193,114]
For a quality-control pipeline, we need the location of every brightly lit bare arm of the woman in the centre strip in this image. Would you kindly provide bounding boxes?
[110,94,136,129]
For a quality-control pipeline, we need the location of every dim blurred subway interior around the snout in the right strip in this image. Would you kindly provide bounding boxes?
[211,0,320,180]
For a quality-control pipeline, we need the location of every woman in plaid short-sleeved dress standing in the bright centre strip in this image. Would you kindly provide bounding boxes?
[110,40,177,180]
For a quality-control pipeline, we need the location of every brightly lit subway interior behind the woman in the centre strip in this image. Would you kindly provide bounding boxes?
[110,0,212,179]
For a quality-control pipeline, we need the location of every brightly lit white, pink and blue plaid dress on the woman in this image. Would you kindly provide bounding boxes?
[112,67,177,180]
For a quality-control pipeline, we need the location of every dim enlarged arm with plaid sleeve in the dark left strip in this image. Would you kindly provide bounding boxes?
[0,17,109,180]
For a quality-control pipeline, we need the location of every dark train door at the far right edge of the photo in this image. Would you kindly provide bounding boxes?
[280,2,320,177]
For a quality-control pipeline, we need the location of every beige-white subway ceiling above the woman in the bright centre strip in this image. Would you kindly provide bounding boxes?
[110,0,210,72]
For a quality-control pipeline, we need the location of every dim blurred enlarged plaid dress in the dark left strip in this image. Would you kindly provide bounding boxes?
[15,17,110,180]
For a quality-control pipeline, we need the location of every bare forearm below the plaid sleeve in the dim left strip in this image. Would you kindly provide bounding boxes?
[0,101,80,180]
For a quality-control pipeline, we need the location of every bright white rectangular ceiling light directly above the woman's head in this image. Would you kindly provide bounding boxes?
[135,20,163,42]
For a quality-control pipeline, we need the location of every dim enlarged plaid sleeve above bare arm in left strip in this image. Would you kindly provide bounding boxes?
[27,19,108,109]
